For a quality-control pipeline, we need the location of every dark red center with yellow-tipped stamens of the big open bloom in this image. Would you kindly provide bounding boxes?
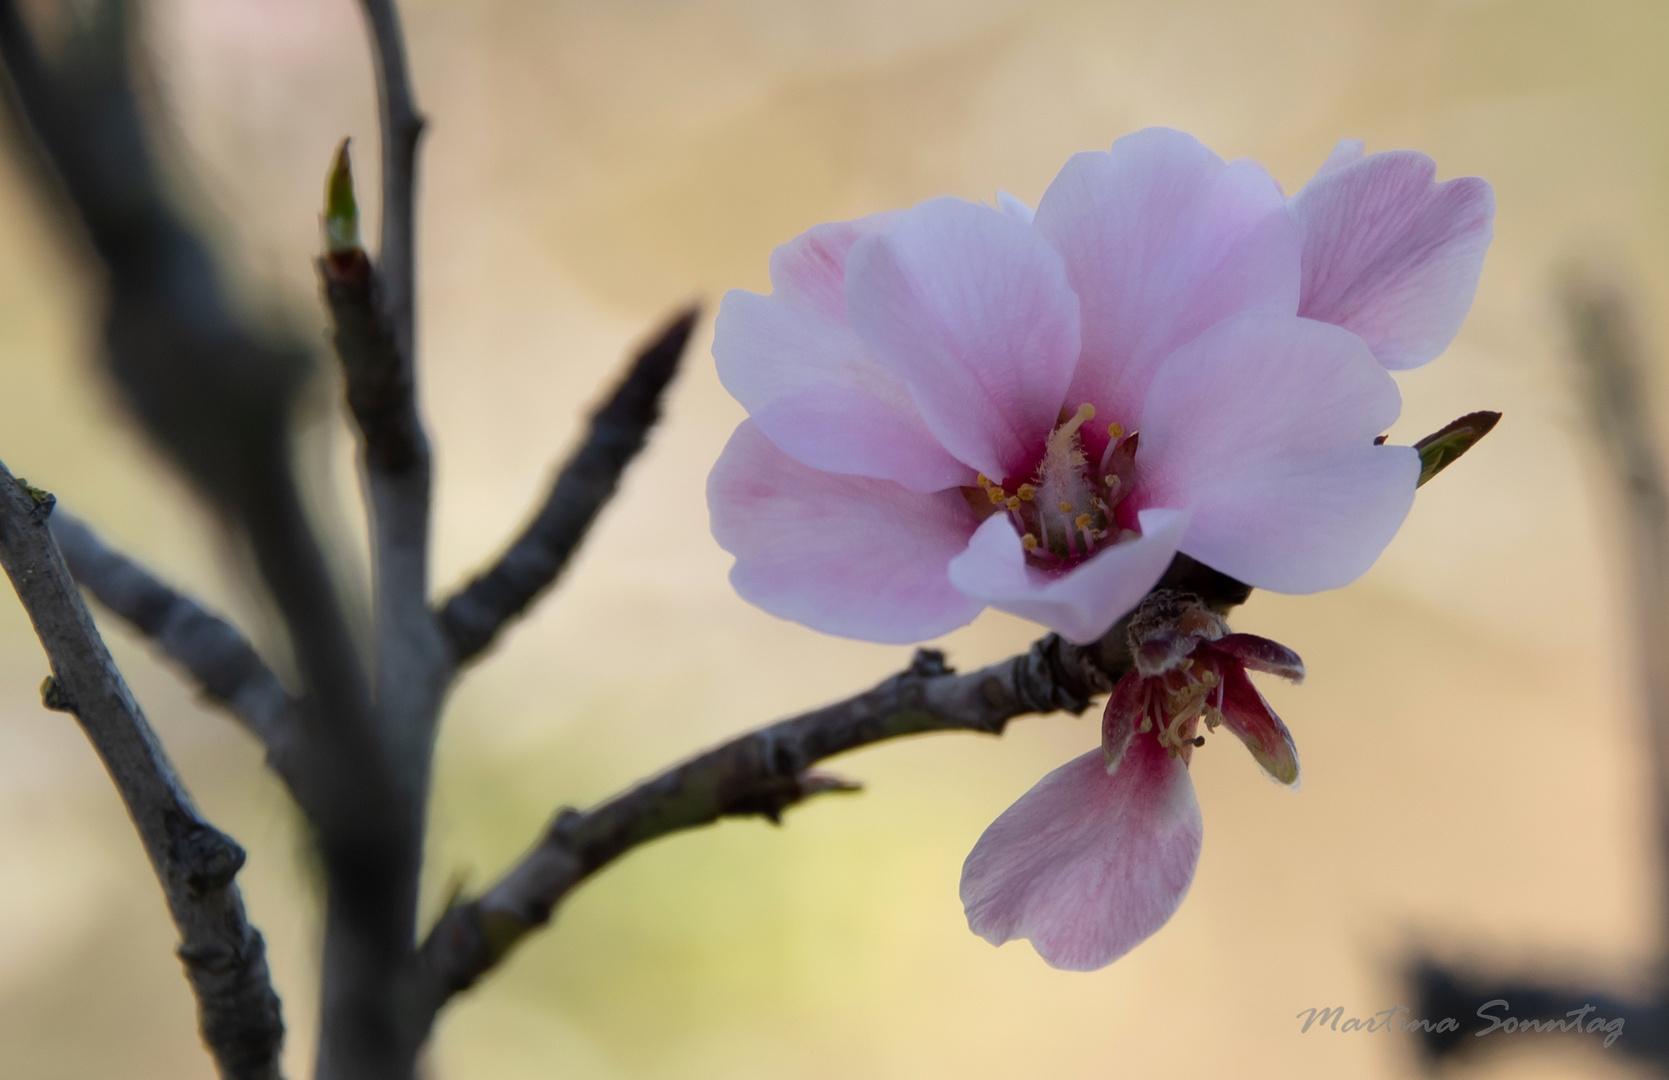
[961,402,1140,569]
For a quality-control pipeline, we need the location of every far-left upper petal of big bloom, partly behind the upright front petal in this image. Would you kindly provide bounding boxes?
[713,214,973,491]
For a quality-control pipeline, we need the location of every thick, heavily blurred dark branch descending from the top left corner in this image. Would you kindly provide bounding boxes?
[0,0,417,1080]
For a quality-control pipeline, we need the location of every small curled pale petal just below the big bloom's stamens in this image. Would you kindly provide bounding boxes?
[950,509,1188,644]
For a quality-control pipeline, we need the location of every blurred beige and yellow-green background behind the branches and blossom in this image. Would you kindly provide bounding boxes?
[0,0,1648,1080]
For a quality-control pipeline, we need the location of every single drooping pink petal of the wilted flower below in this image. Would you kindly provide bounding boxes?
[961,738,1202,971]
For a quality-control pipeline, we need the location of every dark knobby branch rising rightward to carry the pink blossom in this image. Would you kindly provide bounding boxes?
[422,556,1250,1008]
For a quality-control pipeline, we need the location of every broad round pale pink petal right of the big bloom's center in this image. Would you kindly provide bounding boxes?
[1132,315,1420,593]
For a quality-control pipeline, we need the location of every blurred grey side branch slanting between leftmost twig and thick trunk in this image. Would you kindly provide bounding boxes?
[50,507,295,746]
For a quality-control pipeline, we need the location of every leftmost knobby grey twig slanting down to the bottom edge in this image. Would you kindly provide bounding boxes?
[0,464,284,1080]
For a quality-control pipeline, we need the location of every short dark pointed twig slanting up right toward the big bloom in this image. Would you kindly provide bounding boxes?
[441,307,701,666]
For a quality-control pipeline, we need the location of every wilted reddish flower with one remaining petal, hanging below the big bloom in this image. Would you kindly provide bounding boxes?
[961,591,1303,970]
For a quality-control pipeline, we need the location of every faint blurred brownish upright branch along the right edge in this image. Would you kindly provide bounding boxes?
[1564,275,1669,954]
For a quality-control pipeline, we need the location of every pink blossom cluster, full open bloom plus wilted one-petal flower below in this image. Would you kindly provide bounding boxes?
[708,129,1494,968]
